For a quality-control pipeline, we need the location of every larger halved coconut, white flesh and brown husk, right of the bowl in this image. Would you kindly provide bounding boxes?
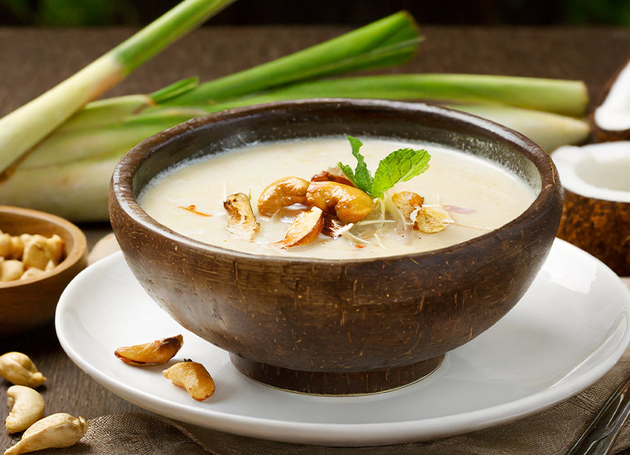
[551,141,630,276]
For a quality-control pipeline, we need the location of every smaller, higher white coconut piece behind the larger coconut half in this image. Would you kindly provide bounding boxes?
[592,60,630,141]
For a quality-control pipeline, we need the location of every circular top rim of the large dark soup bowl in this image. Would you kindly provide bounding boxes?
[110,98,562,266]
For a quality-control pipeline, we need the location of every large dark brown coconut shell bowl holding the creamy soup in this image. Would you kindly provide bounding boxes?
[110,100,562,395]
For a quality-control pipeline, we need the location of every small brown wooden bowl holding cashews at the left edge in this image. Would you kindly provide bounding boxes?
[0,206,87,337]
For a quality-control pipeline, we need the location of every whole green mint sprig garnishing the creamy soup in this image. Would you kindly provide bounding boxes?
[338,136,431,198]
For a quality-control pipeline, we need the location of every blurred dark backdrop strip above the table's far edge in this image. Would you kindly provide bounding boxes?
[0,0,630,27]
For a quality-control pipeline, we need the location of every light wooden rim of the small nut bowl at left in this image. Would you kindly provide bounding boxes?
[0,205,87,291]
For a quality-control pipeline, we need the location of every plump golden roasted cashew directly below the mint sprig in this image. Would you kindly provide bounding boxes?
[306,182,374,223]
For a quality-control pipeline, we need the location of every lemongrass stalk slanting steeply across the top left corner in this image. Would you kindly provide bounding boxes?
[0,0,234,173]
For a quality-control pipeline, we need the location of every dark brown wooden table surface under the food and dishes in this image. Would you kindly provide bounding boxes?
[0,27,630,449]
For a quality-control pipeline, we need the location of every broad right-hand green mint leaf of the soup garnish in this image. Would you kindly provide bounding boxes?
[368,149,431,197]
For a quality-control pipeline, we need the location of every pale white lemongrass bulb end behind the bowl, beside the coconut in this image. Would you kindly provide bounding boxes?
[447,104,591,152]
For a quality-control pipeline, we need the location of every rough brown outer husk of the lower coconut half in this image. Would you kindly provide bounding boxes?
[558,189,630,276]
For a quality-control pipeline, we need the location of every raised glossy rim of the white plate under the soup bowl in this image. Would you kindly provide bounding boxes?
[55,238,630,447]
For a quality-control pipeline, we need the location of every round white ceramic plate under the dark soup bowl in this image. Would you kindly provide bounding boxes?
[56,240,630,446]
